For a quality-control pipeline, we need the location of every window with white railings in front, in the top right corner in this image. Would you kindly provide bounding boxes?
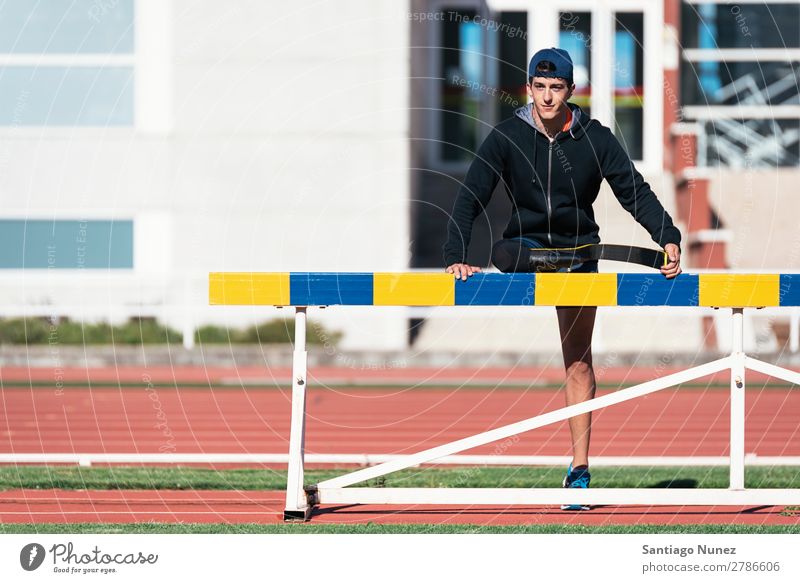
[681,0,800,168]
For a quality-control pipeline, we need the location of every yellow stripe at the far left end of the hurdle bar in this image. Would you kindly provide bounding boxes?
[208,273,291,306]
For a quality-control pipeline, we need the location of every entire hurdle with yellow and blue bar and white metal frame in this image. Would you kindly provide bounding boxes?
[209,272,800,520]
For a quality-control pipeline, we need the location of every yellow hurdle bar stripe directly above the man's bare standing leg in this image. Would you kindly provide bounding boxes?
[534,273,617,306]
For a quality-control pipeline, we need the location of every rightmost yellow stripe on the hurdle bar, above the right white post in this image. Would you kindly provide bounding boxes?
[699,273,780,308]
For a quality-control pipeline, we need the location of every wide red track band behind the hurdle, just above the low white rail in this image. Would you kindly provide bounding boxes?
[0,387,800,456]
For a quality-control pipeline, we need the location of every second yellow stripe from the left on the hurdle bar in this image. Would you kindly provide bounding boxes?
[372,273,456,306]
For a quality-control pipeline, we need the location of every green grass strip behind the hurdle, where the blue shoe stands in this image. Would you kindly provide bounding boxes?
[0,466,800,490]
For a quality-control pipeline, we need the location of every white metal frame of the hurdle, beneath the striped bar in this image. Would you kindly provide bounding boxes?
[284,318,800,520]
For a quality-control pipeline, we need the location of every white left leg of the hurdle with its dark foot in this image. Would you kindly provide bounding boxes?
[283,306,312,520]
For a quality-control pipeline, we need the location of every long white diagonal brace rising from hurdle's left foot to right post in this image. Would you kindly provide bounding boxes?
[317,356,730,488]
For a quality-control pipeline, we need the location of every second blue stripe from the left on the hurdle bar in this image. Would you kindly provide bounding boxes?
[456,273,534,306]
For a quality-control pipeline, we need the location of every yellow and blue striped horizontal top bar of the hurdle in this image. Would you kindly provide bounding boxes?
[209,272,800,308]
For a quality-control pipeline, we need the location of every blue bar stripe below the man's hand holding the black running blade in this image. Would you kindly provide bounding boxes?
[617,273,700,306]
